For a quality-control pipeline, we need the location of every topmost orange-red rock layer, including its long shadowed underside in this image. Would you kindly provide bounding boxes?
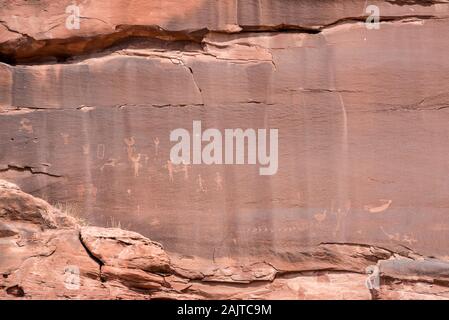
[0,0,448,62]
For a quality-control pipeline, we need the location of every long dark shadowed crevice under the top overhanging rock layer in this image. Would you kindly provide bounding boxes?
[0,15,447,65]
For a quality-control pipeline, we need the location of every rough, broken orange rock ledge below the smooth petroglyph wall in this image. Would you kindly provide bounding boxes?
[0,180,449,299]
